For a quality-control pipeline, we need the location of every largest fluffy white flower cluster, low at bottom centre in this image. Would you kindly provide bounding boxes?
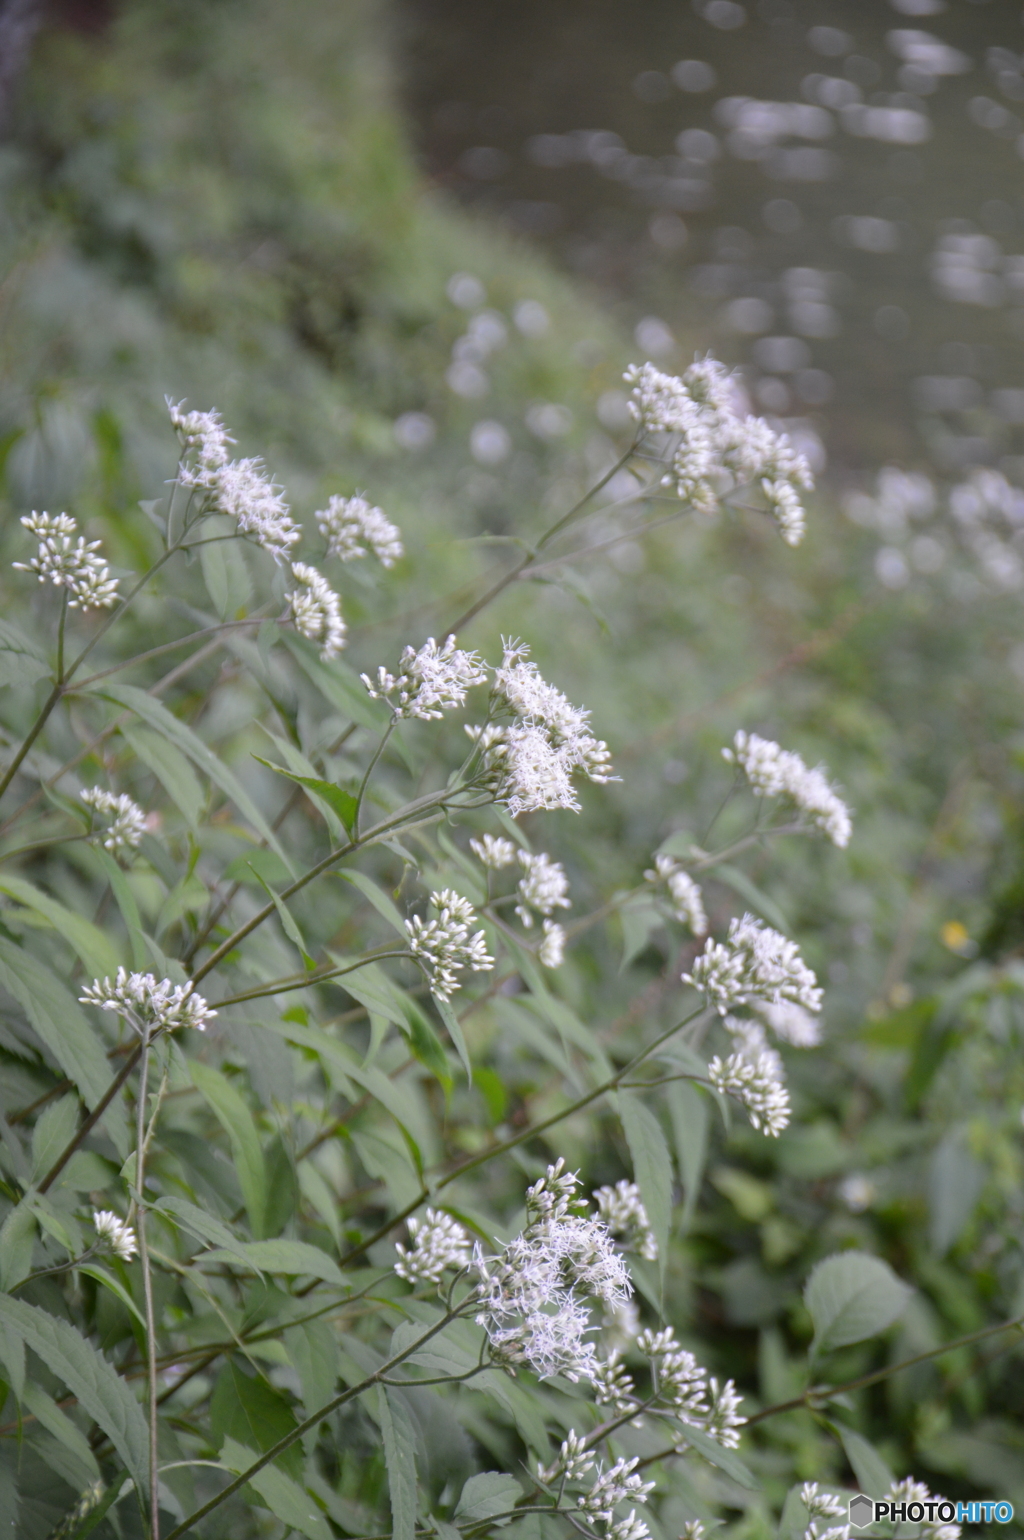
[473,1160,633,1380]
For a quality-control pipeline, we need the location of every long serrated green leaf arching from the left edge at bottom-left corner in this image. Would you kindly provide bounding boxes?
[0,1295,149,1492]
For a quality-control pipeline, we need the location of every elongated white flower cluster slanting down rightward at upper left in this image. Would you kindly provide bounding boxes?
[168,399,302,561]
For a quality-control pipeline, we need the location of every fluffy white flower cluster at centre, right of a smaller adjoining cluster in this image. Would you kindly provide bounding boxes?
[471,641,614,818]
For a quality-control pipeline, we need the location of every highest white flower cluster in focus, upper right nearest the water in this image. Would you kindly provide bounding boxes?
[625,357,815,545]
